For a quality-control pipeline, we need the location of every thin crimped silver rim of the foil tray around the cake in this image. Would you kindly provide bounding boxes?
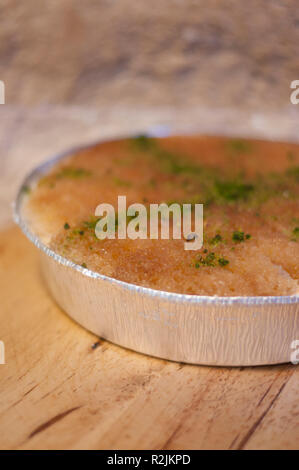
[13,128,299,305]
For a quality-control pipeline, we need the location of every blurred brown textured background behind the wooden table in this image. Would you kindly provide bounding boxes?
[0,0,299,111]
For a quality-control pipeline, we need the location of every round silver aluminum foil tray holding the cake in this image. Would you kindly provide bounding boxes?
[14,134,299,366]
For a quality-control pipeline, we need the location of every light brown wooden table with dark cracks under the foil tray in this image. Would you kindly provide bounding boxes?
[0,107,299,449]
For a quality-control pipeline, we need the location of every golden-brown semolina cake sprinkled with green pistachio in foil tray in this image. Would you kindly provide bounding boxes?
[24,136,299,296]
